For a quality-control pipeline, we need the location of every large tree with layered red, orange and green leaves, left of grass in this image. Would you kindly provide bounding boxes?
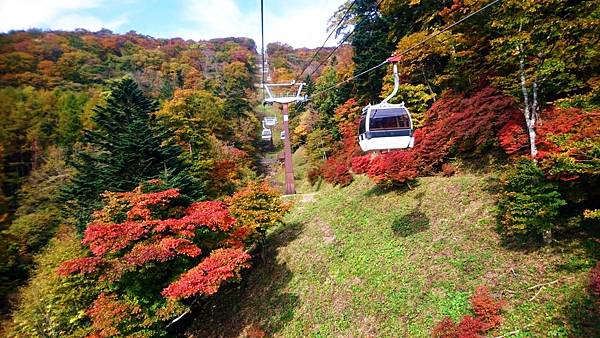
[58,182,289,336]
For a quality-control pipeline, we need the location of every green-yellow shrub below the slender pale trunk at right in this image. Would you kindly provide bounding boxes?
[499,158,566,235]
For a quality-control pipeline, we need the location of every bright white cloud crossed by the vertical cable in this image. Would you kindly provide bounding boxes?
[175,0,344,48]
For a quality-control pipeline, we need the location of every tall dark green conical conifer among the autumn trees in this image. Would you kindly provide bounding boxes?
[62,78,200,232]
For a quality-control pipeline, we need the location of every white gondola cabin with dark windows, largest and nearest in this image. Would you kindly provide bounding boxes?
[358,102,415,152]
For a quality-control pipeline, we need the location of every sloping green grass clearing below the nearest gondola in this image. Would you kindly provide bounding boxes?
[189,175,600,337]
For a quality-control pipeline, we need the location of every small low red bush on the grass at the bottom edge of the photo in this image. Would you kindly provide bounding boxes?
[431,286,505,338]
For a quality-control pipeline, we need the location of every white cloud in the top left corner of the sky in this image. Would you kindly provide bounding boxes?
[0,0,125,32]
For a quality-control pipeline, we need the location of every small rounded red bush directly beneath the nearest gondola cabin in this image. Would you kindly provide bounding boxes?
[367,151,419,184]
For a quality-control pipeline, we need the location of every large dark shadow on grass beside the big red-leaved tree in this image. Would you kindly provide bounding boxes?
[180,223,304,337]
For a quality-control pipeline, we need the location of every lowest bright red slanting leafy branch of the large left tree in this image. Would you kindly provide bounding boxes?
[162,249,250,299]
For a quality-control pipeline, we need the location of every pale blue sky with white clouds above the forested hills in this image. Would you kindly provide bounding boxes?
[0,0,345,48]
